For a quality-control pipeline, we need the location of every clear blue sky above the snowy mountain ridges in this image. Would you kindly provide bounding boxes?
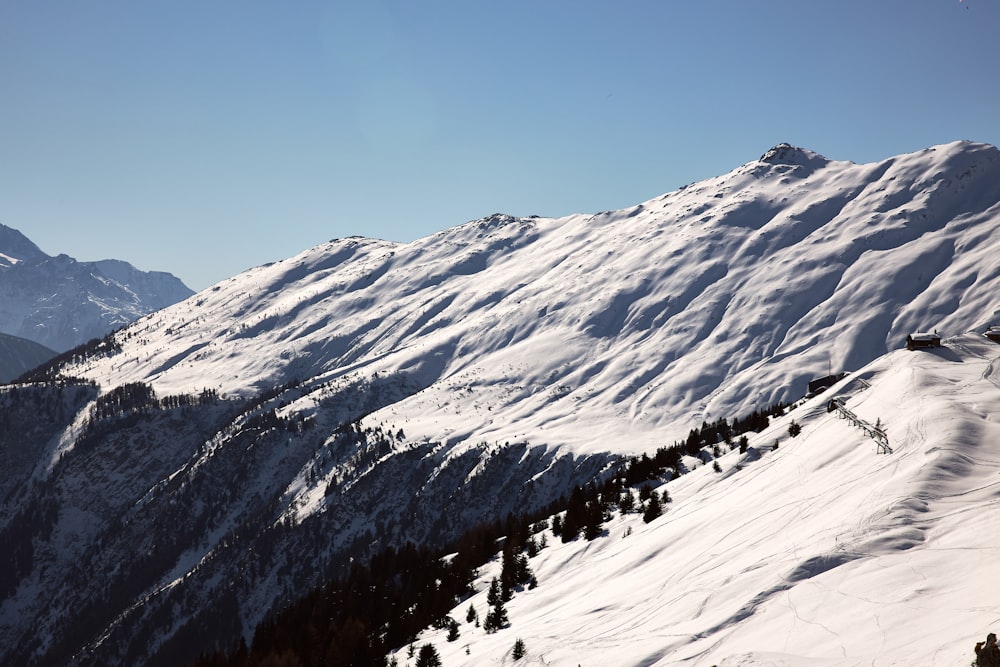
[0,0,1000,289]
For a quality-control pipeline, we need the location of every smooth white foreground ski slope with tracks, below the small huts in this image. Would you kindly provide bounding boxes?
[399,334,1000,667]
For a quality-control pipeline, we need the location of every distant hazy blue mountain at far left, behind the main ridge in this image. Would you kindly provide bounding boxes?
[0,225,193,352]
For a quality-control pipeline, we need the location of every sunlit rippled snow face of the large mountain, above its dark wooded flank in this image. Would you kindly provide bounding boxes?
[60,142,1000,449]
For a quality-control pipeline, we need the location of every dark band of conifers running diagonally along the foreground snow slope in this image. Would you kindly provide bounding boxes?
[186,403,787,667]
